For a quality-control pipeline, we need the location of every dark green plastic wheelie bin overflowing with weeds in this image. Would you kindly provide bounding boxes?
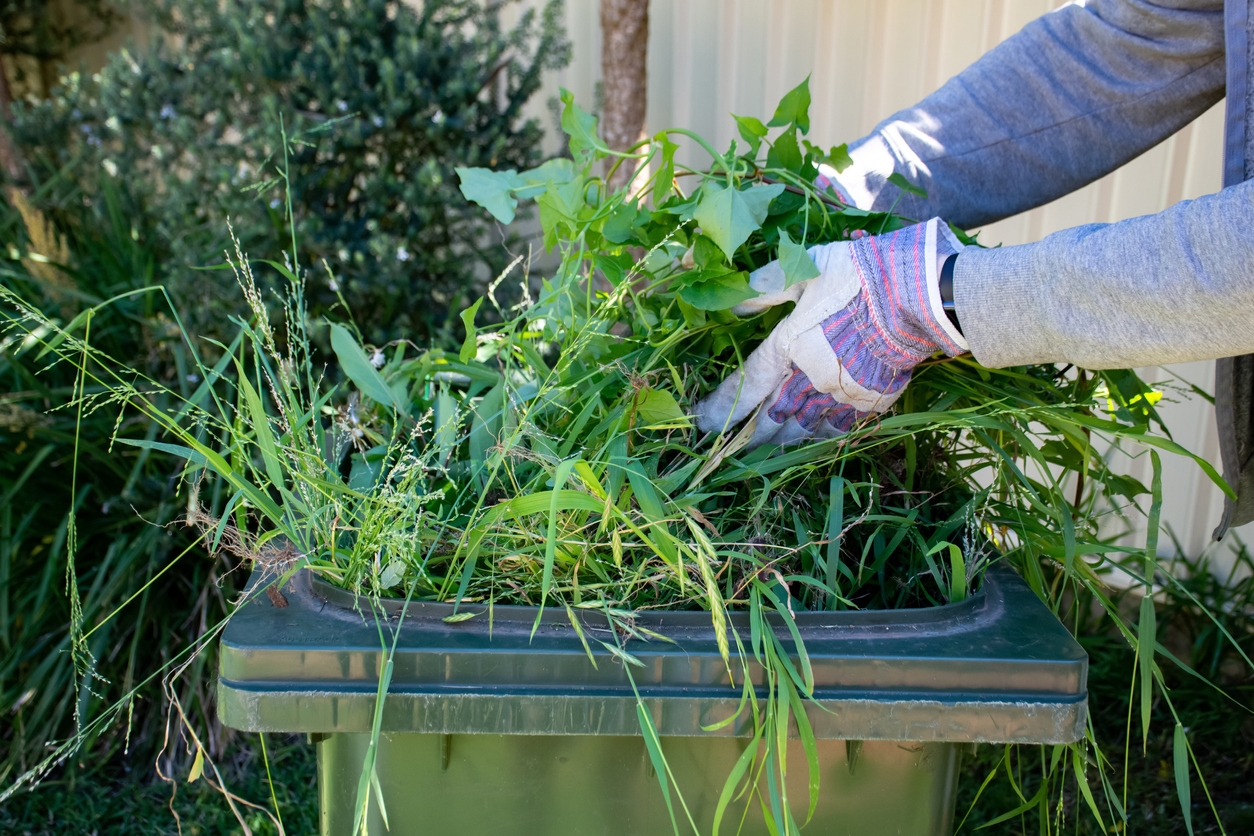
[218,569,1088,836]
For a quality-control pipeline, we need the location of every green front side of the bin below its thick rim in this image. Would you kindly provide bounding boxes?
[319,733,958,836]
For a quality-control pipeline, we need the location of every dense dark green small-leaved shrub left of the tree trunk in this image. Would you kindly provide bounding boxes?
[13,0,568,342]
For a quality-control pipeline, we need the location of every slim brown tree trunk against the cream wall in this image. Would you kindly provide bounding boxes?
[601,0,648,188]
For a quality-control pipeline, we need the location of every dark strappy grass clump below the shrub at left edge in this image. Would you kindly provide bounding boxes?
[0,177,233,785]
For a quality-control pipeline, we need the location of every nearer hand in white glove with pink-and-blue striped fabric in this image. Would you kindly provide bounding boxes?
[696,218,967,447]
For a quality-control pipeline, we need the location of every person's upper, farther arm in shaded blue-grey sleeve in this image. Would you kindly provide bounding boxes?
[839,0,1224,228]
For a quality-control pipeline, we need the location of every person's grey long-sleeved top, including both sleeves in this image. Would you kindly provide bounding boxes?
[840,0,1254,536]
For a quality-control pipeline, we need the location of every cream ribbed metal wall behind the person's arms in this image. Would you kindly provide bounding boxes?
[511,0,1254,569]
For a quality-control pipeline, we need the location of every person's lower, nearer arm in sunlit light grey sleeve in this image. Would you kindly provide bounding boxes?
[953,180,1254,368]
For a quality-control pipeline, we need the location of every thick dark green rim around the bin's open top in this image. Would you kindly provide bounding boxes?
[218,565,1088,743]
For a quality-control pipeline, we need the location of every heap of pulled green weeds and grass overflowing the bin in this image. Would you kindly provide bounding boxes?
[0,84,1243,832]
